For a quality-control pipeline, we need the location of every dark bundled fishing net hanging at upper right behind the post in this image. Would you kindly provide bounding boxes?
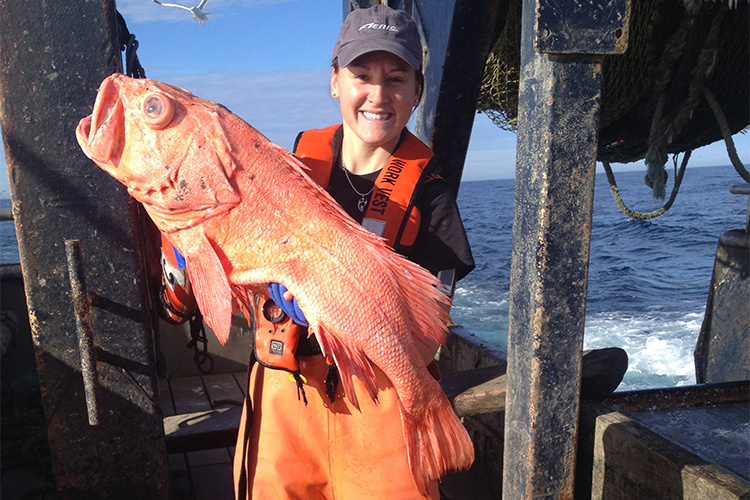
[477,0,750,203]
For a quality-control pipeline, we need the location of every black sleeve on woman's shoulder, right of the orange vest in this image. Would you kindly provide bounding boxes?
[404,177,474,281]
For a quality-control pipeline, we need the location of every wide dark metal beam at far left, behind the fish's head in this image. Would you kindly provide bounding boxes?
[0,0,169,499]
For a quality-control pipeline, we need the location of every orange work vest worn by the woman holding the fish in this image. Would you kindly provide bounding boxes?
[255,124,433,377]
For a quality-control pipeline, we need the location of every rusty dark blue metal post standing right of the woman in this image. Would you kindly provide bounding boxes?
[503,0,630,500]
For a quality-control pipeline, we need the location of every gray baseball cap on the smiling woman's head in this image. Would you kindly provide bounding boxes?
[333,4,422,70]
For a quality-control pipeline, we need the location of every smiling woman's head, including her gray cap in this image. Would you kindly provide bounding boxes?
[331,3,424,175]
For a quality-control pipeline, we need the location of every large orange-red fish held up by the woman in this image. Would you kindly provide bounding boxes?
[76,74,474,492]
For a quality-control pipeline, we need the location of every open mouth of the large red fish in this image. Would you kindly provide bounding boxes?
[76,75,125,164]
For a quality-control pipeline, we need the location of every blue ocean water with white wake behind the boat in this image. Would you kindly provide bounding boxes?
[0,166,748,390]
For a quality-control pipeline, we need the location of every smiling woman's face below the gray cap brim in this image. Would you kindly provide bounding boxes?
[331,51,422,153]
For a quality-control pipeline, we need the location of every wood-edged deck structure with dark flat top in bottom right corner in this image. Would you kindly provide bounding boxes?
[577,381,750,499]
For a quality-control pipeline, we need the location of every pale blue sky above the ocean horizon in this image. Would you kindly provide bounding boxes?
[0,0,750,198]
